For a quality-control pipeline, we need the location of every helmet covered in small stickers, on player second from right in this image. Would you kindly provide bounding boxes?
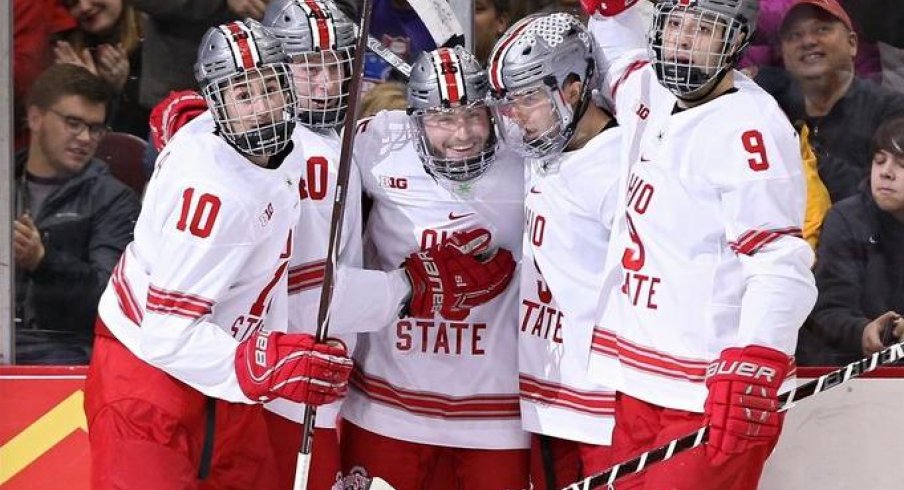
[488,12,596,158]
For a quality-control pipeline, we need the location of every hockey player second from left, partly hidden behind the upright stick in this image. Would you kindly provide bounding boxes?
[262,0,380,490]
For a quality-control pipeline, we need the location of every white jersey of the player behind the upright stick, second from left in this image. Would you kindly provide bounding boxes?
[256,126,408,428]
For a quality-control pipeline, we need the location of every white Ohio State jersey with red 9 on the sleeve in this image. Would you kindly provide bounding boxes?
[590,8,816,412]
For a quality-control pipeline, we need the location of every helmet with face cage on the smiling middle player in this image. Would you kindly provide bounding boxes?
[408,46,497,182]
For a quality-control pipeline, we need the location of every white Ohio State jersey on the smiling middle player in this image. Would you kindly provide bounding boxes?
[342,111,528,449]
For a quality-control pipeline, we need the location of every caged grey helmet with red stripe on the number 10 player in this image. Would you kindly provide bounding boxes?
[194,20,295,156]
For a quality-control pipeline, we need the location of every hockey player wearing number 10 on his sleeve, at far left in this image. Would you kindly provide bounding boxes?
[85,21,351,489]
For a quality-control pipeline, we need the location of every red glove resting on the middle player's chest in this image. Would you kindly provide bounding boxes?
[402,229,515,320]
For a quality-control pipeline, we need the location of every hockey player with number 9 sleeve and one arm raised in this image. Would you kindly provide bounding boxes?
[590,0,816,490]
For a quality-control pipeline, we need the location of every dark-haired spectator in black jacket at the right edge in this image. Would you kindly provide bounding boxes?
[798,116,904,365]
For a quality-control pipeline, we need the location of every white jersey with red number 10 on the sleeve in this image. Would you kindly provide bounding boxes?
[98,113,300,403]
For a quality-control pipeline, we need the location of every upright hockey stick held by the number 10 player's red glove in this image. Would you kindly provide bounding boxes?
[293,0,373,490]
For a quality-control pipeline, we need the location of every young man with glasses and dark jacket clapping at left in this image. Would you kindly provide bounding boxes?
[13,64,140,364]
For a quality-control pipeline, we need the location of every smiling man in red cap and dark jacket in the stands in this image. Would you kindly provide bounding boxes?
[757,0,904,202]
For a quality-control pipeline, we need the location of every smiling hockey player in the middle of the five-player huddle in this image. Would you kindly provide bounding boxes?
[340,47,528,490]
